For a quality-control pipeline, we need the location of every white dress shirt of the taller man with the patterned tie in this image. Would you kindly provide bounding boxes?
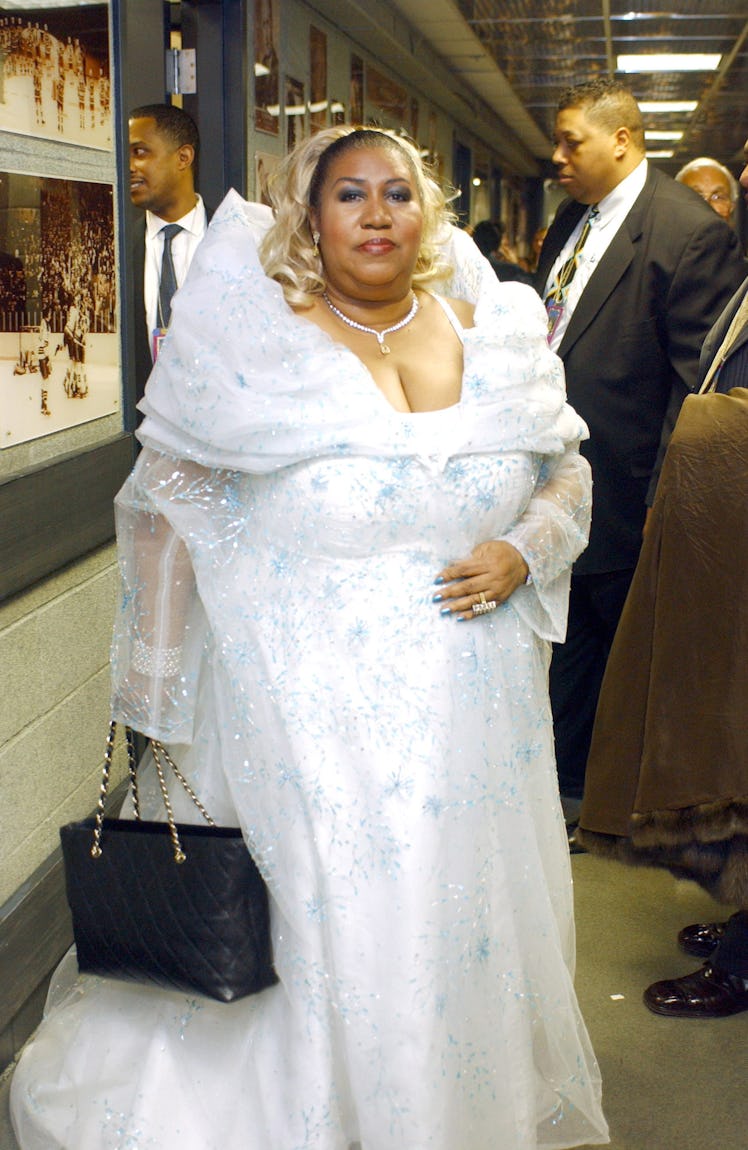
[543,160,647,351]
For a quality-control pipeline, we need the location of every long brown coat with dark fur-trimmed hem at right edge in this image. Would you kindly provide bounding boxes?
[578,389,748,909]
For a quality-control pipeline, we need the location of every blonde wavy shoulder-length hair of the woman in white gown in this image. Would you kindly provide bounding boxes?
[260,124,455,308]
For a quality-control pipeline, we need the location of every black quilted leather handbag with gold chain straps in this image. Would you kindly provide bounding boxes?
[60,722,277,1002]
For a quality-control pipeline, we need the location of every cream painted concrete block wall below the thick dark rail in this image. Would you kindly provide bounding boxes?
[0,545,122,907]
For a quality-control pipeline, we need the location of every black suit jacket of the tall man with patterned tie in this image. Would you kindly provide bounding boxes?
[535,166,745,573]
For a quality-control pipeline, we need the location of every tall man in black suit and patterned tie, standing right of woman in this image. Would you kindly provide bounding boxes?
[536,81,745,849]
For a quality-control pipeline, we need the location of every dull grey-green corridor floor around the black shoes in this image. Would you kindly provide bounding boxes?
[0,854,748,1150]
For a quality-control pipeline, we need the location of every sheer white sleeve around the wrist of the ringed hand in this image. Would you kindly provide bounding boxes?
[503,444,591,642]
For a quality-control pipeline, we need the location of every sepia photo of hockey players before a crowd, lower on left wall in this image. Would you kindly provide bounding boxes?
[0,171,120,451]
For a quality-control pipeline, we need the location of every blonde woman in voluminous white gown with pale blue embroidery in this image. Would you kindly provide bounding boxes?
[12,128,608,1150]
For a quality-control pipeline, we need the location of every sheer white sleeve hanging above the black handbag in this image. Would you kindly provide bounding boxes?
[112,447,209,744]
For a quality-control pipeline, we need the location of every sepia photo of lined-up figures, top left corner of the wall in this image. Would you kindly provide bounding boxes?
[0,3,113,151]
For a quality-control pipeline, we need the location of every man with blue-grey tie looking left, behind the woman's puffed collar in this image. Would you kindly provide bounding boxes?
[129,104,211,409]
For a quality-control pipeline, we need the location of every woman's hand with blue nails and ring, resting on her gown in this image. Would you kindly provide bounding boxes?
[434,539,529,619]
